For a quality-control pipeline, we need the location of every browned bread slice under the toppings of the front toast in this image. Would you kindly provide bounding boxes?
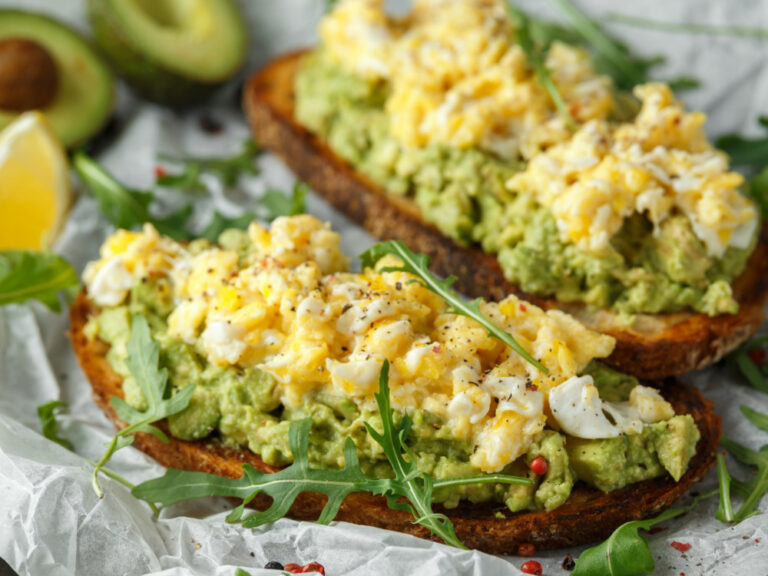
[69,291,720,554]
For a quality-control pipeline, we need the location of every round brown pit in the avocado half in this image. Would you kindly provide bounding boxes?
[0,38,59,112]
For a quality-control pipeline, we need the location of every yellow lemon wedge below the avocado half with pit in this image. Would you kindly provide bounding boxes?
[0,112,72,250]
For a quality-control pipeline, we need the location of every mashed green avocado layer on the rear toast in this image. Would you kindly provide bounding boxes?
[295,52,757,316]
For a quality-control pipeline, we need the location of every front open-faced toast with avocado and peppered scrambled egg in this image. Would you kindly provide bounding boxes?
[71,216,720,553]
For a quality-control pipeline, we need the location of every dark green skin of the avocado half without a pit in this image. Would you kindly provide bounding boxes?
[88,0,247,108]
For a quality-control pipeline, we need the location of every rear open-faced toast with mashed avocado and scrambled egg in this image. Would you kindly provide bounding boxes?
[244,0,768,378]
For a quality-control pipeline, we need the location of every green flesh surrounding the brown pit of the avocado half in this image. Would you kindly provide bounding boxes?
[0,10,114,148]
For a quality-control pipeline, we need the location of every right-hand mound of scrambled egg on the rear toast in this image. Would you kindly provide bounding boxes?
[507,84,758,258]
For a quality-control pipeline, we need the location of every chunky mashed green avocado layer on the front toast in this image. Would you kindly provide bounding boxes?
[86,256,699,512]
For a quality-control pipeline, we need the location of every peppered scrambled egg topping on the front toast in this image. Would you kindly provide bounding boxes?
[84,216,668,472]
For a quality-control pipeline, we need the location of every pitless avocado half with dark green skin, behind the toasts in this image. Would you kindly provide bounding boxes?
[88,0,248,107]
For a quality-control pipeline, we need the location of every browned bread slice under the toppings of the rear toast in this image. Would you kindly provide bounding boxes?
[243,52,768,380]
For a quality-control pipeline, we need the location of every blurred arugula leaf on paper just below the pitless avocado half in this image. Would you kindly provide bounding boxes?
[157,140,261,191]
